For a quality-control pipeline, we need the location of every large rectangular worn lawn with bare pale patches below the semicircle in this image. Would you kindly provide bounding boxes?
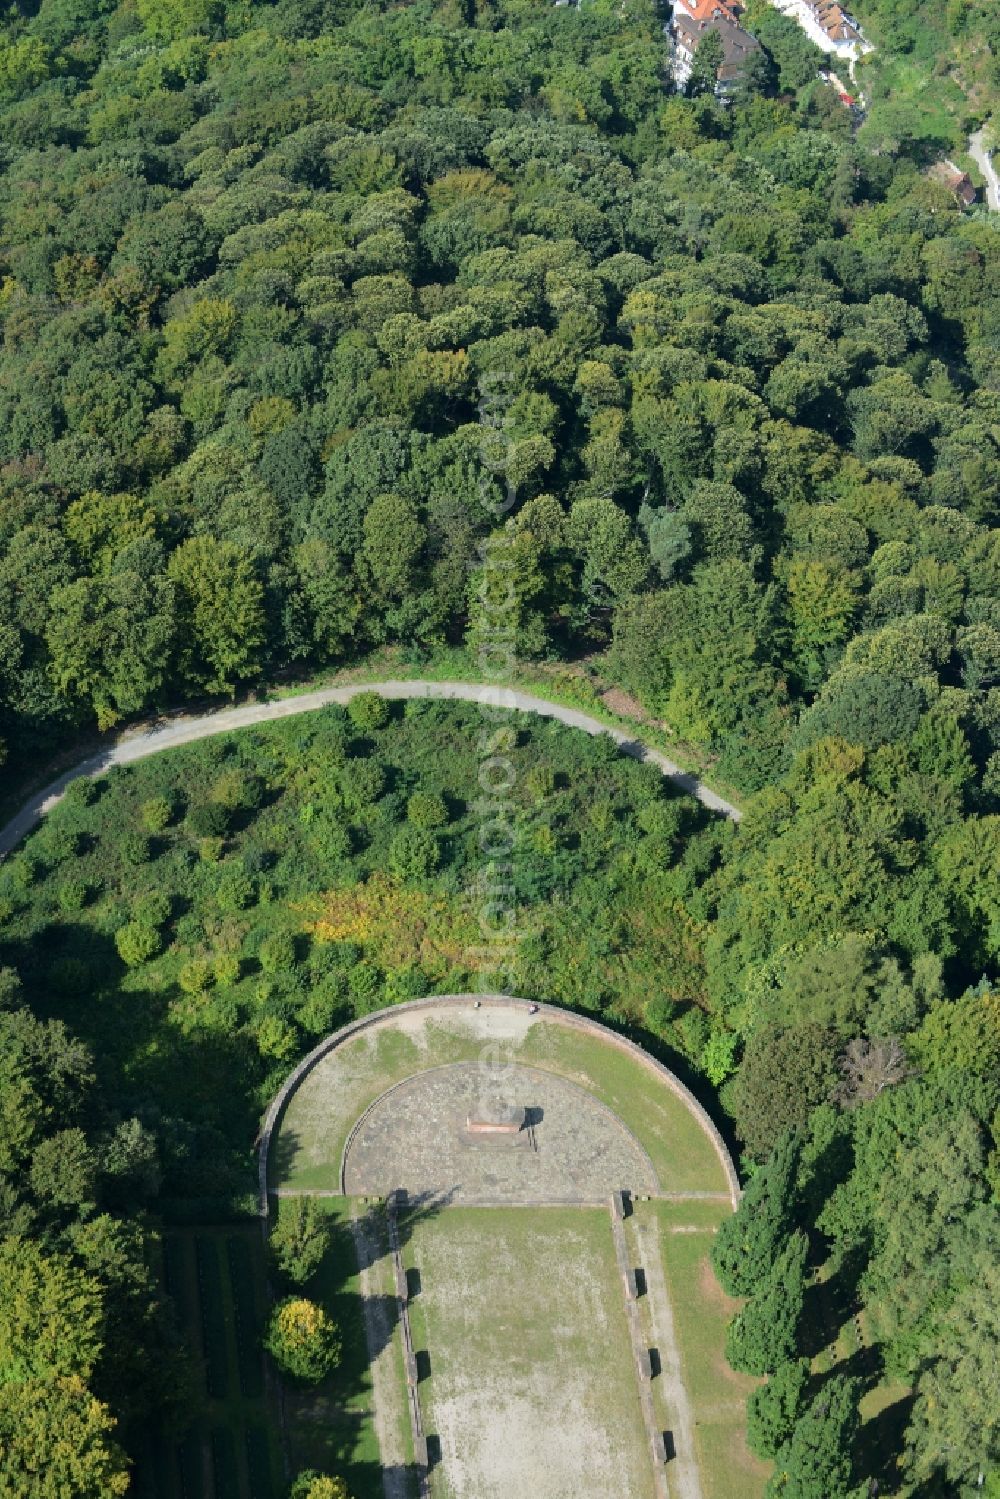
[402,1208,654,1499]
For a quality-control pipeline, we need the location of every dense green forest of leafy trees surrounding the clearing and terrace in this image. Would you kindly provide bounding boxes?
[0,0,1000,1499]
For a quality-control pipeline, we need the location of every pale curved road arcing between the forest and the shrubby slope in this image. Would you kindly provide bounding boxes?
[0,681,742,859]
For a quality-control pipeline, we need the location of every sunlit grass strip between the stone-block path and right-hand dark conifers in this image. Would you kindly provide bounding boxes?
[636,1202,771,1499]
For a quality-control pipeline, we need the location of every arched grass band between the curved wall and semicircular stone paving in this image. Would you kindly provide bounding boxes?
[270,1007,727,1192]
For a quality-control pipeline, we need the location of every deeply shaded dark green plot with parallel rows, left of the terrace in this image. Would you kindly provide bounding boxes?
[135,1228,285,1499]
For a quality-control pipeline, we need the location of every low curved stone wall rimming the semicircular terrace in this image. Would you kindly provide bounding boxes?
[258,994,741,1220]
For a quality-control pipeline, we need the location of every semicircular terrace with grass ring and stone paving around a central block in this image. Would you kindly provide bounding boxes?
[261,995,739,1213]
